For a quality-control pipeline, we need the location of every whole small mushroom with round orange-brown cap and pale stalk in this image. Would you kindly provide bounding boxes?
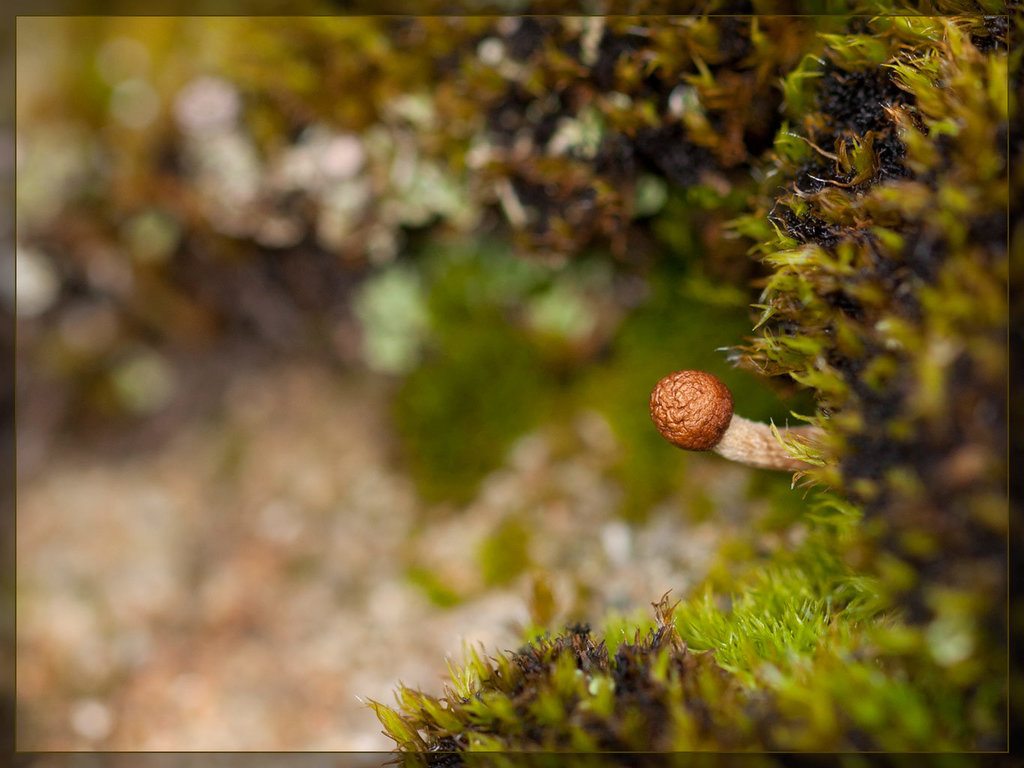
[650,371,821,470]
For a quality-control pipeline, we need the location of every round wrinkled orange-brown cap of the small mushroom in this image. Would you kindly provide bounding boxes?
[650,371,732,451]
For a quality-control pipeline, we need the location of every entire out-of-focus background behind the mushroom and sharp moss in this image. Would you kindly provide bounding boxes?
[12,16,813,751]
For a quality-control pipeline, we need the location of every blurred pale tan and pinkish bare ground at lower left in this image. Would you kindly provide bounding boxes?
[17,348,749,751]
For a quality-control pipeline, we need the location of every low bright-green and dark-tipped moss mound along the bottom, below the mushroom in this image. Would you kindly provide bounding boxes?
[372,505,998,765]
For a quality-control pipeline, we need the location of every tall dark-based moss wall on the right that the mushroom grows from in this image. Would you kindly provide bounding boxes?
[748,17,1009,680]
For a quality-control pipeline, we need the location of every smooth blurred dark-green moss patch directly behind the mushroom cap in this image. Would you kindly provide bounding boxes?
[385,242,811,520]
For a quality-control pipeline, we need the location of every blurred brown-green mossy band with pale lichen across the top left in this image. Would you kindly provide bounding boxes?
[17,15,813,434]
